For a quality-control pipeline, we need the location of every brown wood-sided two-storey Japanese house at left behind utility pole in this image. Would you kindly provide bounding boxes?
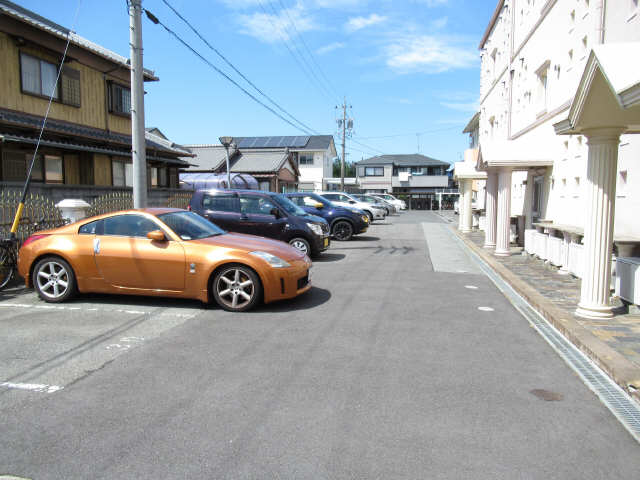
[0,0,191,204]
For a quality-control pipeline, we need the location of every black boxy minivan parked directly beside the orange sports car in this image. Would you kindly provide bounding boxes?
[189,189,330,257]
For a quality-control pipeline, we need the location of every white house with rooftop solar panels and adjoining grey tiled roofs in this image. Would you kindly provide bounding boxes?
[182,135,336,192]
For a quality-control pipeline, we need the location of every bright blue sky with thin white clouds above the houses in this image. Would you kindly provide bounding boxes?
[14,0,496,162]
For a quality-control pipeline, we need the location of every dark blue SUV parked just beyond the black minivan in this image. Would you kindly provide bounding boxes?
[286,193,369,240]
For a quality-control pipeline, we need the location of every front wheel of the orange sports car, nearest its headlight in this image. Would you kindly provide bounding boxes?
[212,265,262,312]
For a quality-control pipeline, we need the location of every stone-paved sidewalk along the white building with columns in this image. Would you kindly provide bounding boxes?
[451,225,640,402]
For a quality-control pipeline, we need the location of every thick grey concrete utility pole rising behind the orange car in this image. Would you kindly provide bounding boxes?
[129,0,147,208]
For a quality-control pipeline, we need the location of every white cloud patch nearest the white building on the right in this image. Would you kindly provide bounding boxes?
[384,35,478,73]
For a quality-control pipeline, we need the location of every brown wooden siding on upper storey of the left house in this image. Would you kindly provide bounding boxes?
[0,33,131,134]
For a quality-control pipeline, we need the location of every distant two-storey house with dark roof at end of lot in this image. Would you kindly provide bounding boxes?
[356,154,452,208]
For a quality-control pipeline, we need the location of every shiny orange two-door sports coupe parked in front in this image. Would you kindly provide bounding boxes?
[18,208,311,312]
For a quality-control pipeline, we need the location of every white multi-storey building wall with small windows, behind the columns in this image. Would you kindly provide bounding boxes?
[479,0,640,236]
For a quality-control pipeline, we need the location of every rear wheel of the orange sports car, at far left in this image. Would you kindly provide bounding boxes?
[33,257,76,303]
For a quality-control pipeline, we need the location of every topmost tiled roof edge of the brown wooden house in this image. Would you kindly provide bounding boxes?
[0,0,158,80]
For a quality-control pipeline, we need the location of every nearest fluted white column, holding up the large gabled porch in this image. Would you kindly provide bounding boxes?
[576,128,622,318]
